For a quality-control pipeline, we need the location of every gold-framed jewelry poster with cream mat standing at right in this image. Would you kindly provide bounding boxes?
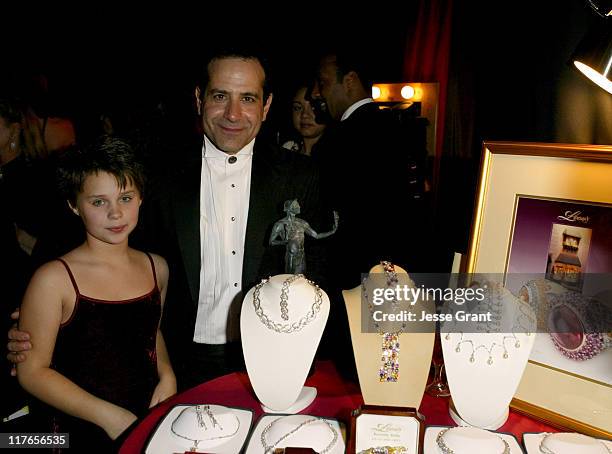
[465,142,612,437]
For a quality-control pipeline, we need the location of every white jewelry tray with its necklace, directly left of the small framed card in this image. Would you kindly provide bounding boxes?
[245,415,345,454]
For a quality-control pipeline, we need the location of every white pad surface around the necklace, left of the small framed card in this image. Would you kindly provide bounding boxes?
[245,415,346,454]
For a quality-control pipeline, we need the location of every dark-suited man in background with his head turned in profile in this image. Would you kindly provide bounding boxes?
[312,48,427,289]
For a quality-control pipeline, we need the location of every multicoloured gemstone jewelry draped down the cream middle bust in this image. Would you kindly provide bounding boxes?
[361,261,406,383]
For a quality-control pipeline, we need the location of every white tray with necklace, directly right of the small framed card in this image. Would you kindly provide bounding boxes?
[423,426,523,454]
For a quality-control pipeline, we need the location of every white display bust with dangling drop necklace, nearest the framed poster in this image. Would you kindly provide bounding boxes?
[440,283,535,430]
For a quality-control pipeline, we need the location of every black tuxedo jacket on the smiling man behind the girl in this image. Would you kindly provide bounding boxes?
[142,139,331,369]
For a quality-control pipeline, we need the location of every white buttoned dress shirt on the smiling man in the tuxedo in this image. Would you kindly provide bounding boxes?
[193,136,255,344]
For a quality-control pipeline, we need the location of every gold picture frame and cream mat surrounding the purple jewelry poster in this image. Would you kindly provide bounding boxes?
[464,142,612,438]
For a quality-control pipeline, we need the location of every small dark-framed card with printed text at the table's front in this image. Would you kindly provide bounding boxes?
[348,405,425,454]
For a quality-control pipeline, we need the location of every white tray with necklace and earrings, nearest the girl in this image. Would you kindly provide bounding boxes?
[144,404,253,454]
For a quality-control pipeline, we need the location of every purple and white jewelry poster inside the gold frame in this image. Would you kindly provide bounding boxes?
[507,196,612,385]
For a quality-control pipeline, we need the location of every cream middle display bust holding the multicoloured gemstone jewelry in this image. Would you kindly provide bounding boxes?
[342,265,435,408]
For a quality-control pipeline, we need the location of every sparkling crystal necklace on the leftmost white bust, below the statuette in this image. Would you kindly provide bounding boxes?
[253,274,323,334]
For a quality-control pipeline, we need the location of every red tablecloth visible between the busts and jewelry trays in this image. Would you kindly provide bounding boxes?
[119,361,557,454]
